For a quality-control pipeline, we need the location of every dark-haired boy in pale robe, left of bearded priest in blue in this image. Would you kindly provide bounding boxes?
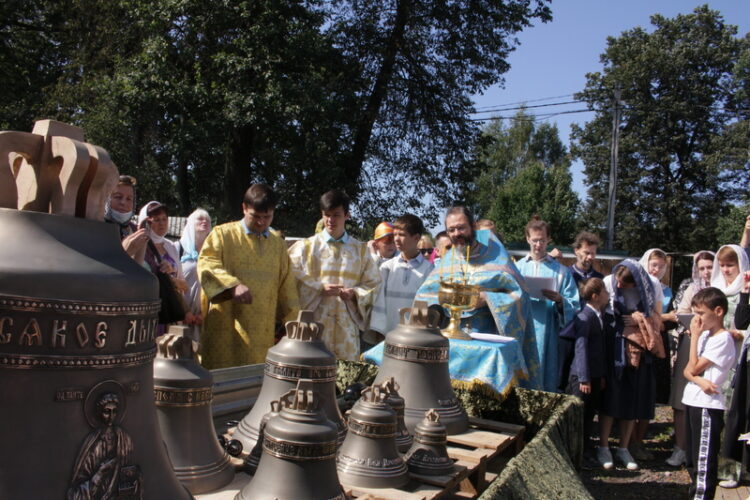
[370,214,433,335]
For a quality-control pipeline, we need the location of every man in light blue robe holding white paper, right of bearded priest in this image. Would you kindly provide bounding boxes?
[518,216,580,392]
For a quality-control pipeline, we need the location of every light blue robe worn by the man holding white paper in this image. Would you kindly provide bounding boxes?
[517,255,581,392]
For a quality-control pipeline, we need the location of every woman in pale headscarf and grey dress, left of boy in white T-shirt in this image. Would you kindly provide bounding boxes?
[667,250,714,467]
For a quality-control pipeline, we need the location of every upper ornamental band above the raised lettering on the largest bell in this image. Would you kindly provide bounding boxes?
[0,295,161,316]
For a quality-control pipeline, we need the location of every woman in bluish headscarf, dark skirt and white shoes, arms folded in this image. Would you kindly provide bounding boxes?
[597,259,664,470]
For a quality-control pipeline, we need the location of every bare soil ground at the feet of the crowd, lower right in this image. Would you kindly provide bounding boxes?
[581,406,690,500]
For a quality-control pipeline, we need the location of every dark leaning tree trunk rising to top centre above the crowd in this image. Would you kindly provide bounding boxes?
[351,0,411,190]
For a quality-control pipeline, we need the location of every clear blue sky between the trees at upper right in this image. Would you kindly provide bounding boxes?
[475,0,750,198]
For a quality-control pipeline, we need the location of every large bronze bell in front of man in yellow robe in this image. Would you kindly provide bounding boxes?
[233,311,346,450]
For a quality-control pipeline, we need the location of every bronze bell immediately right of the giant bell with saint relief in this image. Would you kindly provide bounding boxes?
[154,325,234,495]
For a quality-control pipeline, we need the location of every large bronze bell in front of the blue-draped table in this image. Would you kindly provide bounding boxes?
[375,301,469,435]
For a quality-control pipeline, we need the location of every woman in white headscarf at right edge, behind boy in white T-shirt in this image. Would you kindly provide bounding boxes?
[711,245,750,488]
